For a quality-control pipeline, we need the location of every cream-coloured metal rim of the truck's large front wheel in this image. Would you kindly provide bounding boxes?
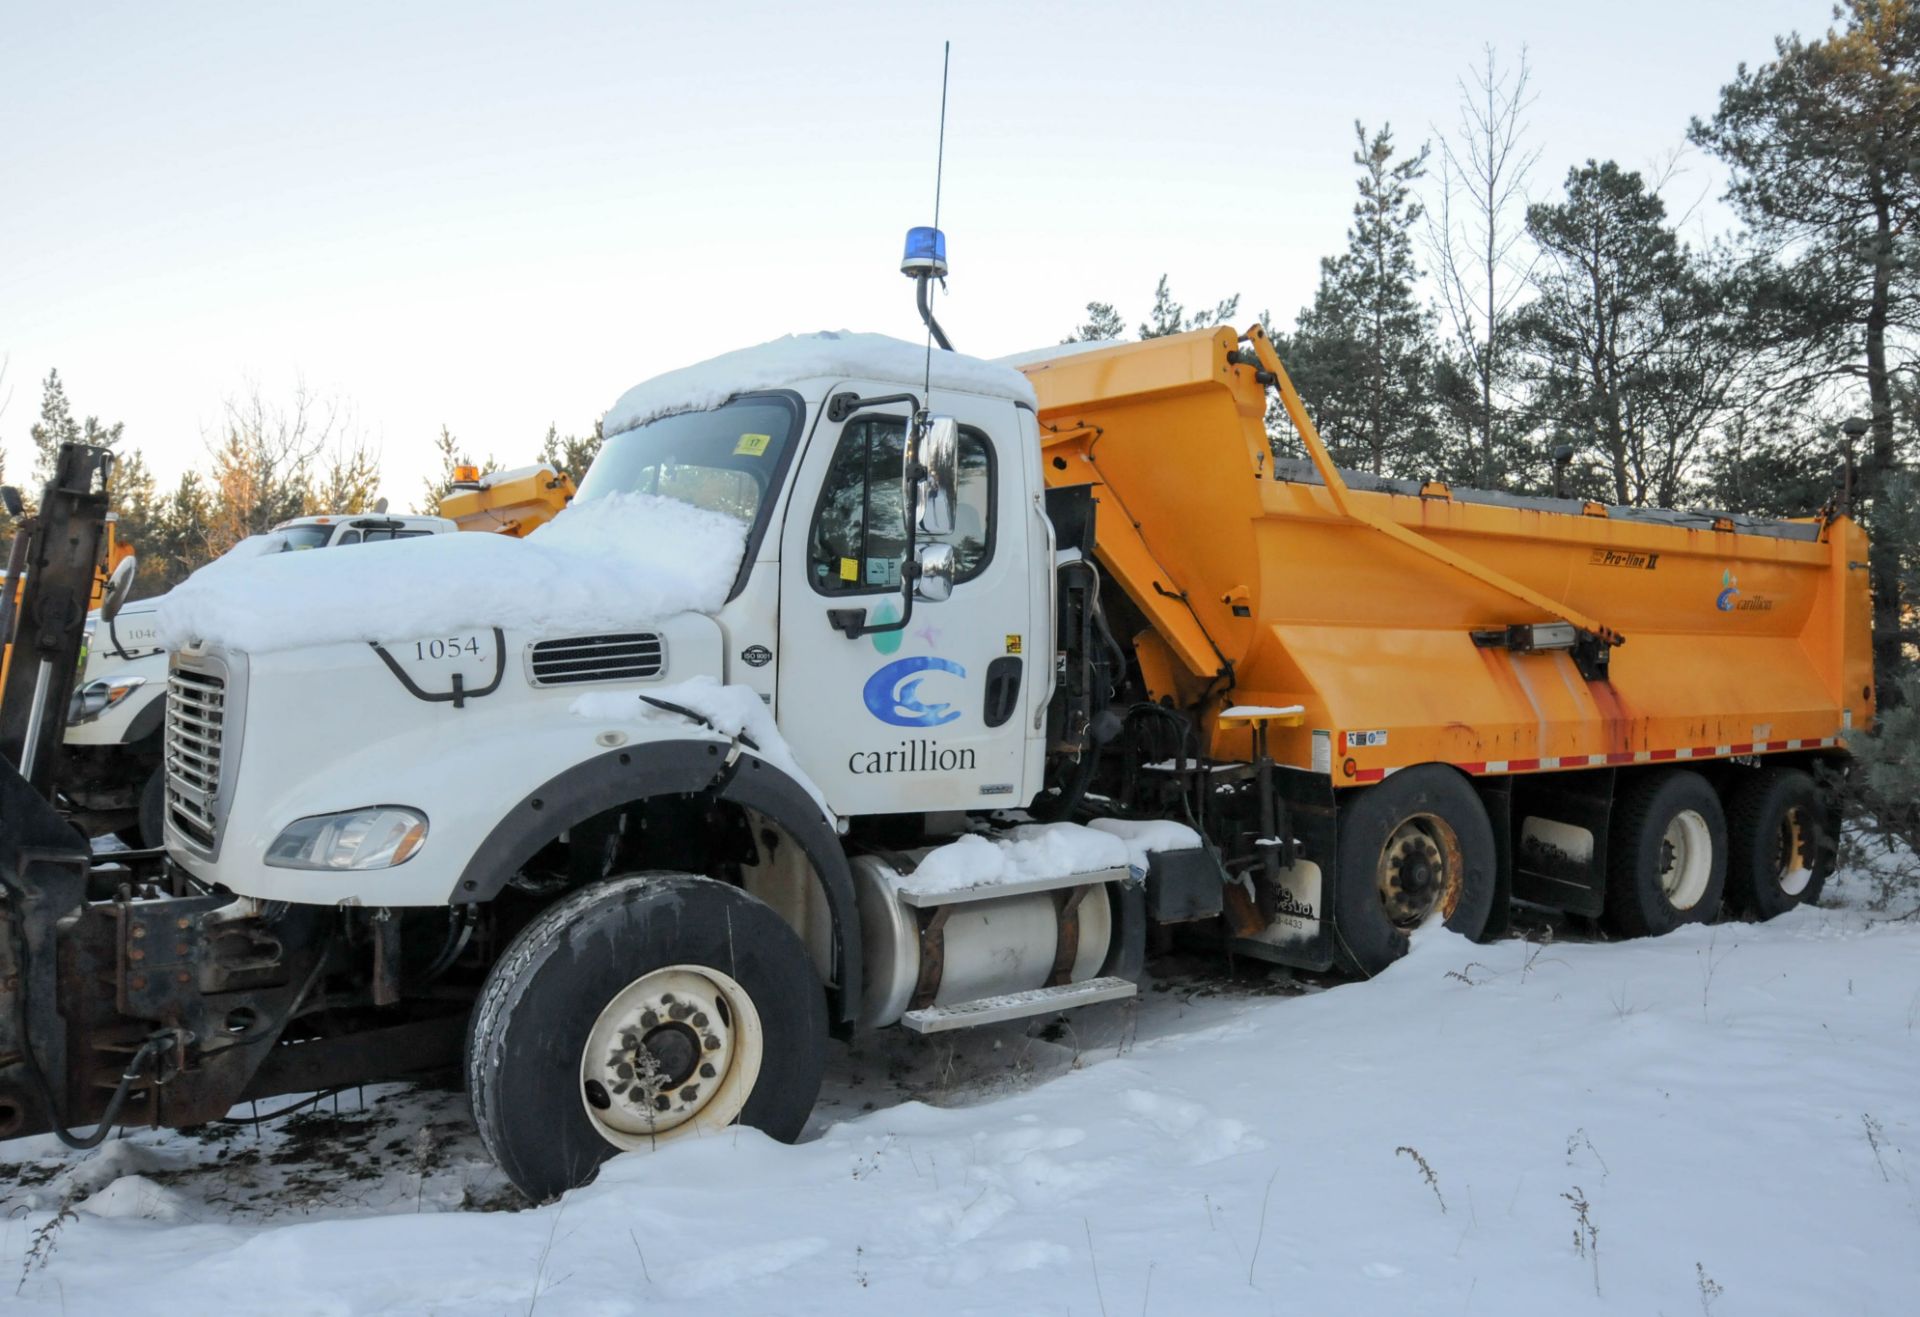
[580,966,764,1148]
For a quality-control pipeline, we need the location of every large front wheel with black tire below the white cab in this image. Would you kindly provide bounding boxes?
[467,874,826,1202]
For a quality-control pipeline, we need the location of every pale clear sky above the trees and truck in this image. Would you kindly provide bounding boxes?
[0,0,1830,507]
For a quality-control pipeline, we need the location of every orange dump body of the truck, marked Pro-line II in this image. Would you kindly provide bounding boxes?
[1021,328,1872,785]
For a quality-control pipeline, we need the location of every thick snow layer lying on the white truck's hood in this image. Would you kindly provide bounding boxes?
[157,493,747,653]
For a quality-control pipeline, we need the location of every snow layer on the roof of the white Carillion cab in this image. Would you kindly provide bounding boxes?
[601,330,1035,434]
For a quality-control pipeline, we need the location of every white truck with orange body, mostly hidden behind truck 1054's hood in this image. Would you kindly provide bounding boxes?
[56,463,574,847]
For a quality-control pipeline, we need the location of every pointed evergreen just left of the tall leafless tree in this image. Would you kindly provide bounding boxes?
[1286,123,1434,476]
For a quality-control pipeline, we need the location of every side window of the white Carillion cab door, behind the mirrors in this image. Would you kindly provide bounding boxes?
[806,417,993,595]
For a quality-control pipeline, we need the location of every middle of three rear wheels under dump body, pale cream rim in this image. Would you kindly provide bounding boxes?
[1607,770,1728,937]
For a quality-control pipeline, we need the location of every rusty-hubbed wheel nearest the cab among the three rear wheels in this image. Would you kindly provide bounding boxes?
[1332,764,1500,977]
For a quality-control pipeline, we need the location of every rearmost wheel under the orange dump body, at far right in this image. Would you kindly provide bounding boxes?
[1726,768,1834,920]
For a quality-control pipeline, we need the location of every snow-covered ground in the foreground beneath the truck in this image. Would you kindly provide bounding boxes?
[0,875,1920,1317]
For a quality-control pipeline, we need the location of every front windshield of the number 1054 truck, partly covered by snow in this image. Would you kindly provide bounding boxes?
[574,394,801,529]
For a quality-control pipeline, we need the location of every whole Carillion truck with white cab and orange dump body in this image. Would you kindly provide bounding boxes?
[0,240,1872,1198]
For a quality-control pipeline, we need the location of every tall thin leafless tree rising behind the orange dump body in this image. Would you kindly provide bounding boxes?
[1427,46,1540,486]
